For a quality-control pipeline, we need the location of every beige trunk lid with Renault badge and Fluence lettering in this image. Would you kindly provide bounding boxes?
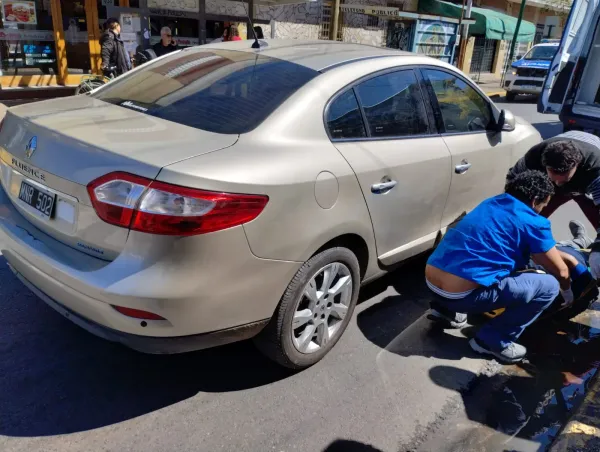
[0,96,239,260]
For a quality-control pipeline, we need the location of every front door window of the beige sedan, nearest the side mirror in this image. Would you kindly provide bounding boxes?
[423,69,493,133]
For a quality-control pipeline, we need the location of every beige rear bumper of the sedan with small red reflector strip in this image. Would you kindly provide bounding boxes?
[0,182,302,351]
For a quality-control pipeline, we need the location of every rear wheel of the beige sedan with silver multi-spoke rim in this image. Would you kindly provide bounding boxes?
[254,248,360,370]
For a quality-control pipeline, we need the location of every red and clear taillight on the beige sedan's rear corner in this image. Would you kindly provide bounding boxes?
[87,172,269,236]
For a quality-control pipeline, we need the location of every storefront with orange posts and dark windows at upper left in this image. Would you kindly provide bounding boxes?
[0,0,269,89]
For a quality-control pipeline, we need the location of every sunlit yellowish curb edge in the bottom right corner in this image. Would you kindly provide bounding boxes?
[550,371,600,452]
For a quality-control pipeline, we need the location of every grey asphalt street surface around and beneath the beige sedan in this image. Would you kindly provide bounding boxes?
[0,101,592,452]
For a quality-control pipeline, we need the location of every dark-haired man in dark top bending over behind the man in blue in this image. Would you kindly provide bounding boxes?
[507,131,600,280]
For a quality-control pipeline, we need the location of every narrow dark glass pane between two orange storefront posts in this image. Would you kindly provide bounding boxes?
[60,0,92,74]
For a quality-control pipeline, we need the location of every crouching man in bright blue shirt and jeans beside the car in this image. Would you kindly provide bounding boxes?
[425,171,573,363]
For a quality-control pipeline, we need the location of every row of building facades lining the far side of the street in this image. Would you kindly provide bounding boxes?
[0,0,572,89]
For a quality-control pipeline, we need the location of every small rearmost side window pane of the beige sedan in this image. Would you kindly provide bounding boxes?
[327,89,367,139]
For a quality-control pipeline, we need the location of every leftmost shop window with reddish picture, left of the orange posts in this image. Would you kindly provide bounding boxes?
[0,0,58,75]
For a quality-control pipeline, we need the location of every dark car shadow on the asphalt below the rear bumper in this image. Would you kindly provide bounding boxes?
[0,256,291,436]
